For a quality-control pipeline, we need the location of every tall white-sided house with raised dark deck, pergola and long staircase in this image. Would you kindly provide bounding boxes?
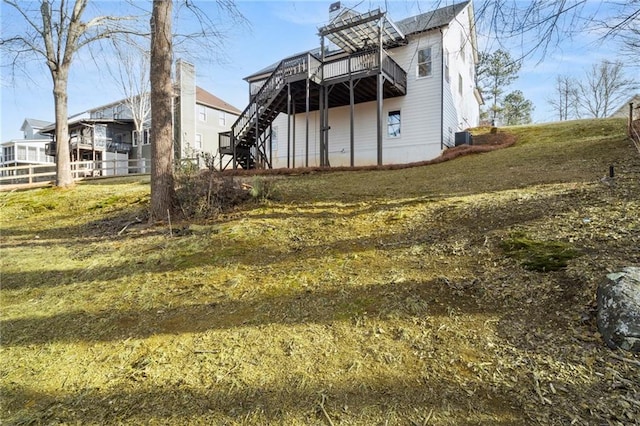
[220,1,482,168]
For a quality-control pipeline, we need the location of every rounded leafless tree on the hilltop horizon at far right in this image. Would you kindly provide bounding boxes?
[580,61,636,118]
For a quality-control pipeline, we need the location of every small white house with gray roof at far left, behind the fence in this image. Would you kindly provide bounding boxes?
[0,118,55,171]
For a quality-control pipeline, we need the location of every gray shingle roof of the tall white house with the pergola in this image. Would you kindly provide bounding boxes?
[244,0,470,81]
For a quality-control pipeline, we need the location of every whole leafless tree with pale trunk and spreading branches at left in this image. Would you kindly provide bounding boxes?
[0,0,138,187]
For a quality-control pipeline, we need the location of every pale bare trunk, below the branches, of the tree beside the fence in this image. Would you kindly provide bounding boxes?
[52,69,74,188]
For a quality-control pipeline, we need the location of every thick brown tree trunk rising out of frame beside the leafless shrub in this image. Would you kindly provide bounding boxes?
[150,0,176,220]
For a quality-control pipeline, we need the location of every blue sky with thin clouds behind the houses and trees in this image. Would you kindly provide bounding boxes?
[0,0,640,142]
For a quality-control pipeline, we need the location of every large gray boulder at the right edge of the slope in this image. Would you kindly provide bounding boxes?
[597,267,640,352]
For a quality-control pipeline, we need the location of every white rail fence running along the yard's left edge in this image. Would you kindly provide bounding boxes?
[0,158,151,188]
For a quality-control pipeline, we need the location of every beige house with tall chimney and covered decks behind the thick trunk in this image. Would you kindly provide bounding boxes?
[36,60,240,175]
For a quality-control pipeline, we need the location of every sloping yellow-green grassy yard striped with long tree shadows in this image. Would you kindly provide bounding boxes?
[0,120,640,425]
